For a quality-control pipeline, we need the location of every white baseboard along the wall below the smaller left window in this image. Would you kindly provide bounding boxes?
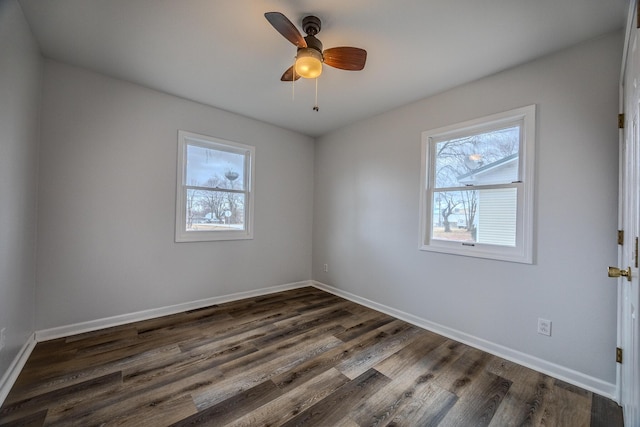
[35,281,313,342]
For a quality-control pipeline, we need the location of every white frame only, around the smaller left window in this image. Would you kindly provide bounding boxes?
[175,130,255,242]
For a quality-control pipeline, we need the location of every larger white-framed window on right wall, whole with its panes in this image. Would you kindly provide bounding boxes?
[420,105,535,264]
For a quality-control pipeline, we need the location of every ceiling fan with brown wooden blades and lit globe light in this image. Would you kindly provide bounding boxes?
[264,12,367,82]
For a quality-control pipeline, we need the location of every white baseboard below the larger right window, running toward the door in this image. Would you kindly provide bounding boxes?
[313,281,617,400]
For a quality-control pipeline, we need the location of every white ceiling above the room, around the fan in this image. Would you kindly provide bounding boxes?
[20,0,626,136]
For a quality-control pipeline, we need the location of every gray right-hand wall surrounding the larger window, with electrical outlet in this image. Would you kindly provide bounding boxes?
[313,33,622,383]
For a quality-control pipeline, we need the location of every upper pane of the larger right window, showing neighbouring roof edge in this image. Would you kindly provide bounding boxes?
[434,126,520,188]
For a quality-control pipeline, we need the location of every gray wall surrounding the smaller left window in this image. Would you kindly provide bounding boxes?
[36,61,313,329]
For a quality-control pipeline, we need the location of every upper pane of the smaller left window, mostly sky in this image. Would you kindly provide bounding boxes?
[186,144,245,190]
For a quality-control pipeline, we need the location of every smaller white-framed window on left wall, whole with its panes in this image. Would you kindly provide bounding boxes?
[176,131,255,242]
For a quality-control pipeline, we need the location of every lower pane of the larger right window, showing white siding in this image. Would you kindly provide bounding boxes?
[431,188,518,247]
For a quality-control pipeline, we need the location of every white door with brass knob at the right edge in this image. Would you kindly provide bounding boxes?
[618,1,640,427]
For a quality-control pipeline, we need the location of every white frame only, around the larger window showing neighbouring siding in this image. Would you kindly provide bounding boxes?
[419,105,536,264]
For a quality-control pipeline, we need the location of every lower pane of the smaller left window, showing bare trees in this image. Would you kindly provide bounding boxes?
[186,189,245,231]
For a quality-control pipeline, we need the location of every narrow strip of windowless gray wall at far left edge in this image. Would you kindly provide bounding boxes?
[0,0,42,378]
